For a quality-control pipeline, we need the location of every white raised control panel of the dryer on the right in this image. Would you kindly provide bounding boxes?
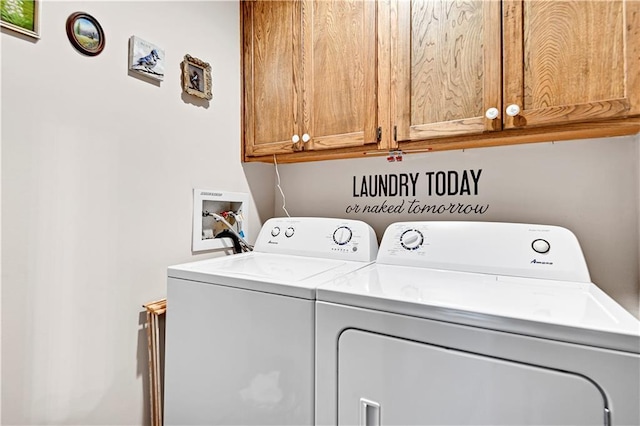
[376,221,591,282]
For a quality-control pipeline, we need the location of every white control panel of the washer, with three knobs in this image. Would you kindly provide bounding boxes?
[254,217,378,262]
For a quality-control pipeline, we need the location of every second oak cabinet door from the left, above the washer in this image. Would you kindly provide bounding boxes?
[302,0,378,150]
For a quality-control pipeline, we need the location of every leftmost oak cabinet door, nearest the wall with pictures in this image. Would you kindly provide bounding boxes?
[240,0,302,156]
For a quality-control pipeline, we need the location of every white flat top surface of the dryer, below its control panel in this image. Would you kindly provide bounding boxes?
[317,264,640,353]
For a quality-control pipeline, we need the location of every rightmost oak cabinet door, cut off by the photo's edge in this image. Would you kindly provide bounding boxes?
[504,0,640,128]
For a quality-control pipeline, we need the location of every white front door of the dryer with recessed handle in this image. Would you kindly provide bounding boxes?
[338,330,606,426]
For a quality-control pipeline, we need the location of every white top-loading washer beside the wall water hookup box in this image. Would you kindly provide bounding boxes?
[164,218,378,425]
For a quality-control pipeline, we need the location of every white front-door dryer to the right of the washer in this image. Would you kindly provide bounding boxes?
[316,222,640,425]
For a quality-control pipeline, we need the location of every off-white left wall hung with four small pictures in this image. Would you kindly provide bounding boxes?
[1,0,274,425]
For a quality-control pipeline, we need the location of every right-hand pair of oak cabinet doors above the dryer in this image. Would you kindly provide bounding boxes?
[391,0,640,147]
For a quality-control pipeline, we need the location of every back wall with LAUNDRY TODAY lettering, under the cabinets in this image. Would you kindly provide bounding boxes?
[276,135,640,316]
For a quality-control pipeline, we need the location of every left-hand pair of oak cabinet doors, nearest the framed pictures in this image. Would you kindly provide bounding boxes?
[241,0,379,161]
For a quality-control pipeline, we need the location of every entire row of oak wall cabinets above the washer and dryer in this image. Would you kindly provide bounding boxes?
[240,0,640,162]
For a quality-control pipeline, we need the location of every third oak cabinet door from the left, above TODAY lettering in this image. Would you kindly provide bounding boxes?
[391,0,502,141]
